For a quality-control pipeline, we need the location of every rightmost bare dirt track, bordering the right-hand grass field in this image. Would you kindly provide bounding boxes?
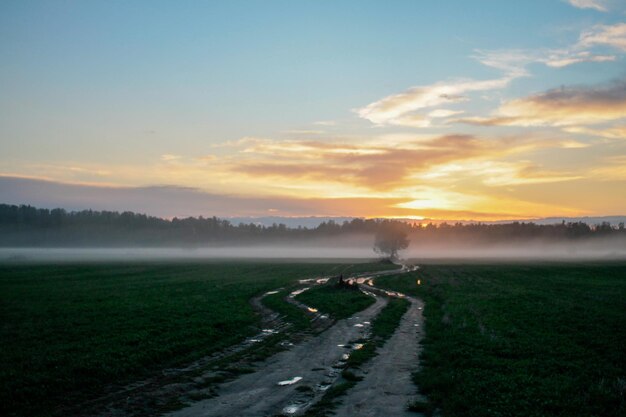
[335,286,423,417]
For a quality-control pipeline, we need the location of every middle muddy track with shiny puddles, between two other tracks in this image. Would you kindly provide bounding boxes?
[169,297,387,417]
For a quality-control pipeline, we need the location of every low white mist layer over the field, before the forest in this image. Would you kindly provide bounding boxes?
[0,235,626,262]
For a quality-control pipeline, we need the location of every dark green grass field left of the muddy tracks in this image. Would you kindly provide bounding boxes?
[0,261,386,416]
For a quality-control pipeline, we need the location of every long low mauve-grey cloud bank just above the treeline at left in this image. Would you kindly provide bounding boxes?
[0,175,478,218]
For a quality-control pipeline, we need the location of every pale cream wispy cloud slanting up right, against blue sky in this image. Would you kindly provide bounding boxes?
[356,74,518,127]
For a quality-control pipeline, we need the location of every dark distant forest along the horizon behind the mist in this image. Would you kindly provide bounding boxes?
[0,204,626,247]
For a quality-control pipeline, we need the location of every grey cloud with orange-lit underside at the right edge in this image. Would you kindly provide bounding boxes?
[460,79,626,127]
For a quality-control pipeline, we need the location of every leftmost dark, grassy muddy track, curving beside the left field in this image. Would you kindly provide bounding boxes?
[69,264,410,417]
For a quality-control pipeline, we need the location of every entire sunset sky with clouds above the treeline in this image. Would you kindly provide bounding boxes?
[0,0,626,220]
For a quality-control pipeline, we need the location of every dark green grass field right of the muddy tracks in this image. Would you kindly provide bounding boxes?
[377,263,626,417]
